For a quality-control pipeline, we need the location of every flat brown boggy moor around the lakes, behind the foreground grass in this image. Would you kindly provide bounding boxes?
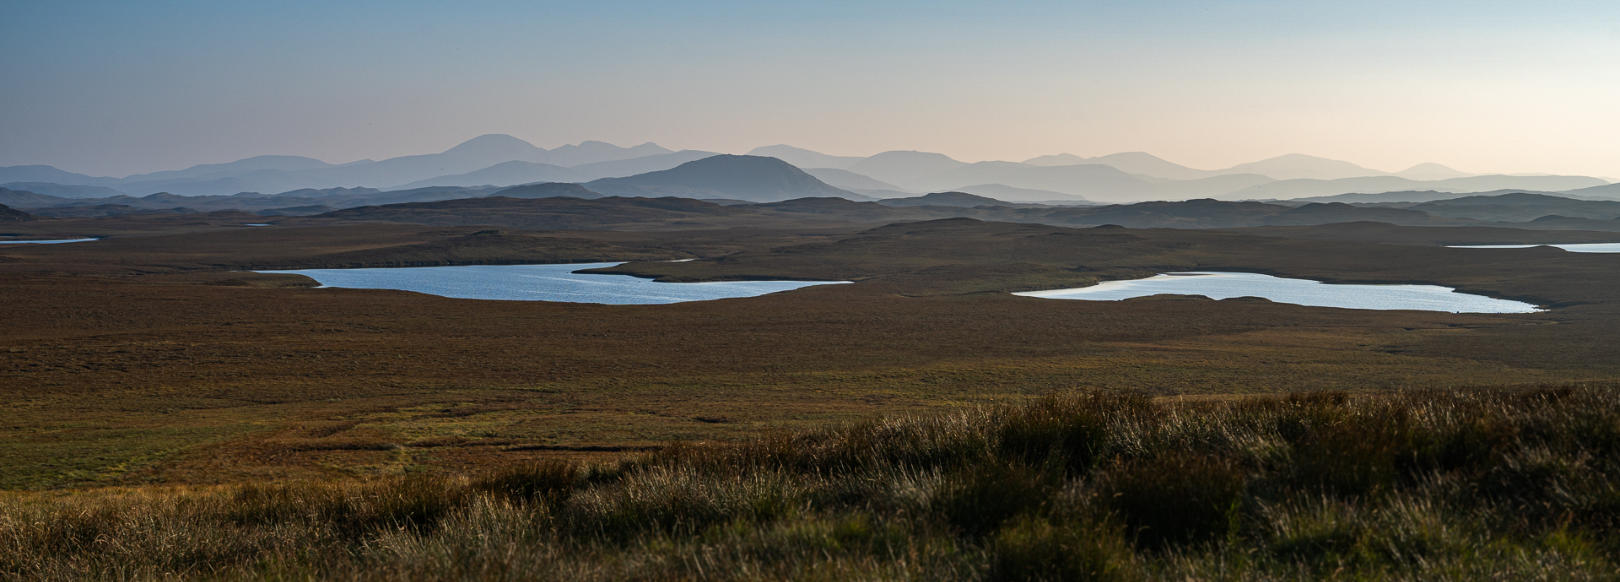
[0,214,1620,488]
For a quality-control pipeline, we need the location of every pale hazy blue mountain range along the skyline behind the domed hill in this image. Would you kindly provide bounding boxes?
[0,135,1620,204]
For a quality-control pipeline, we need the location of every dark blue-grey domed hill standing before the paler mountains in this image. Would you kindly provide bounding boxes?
[585,154,859,203]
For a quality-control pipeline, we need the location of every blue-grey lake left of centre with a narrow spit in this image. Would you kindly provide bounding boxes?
[258,263,847,305]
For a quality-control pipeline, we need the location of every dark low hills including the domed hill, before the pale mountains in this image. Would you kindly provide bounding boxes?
[12,163,1620,232]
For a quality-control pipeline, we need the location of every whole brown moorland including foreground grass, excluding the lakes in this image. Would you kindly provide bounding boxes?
[0,212,1620,579]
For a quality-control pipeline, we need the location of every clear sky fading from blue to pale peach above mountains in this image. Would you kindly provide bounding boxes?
[0,0,1620,178]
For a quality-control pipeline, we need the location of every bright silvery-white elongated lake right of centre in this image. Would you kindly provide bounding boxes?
[1014,272,1541,313]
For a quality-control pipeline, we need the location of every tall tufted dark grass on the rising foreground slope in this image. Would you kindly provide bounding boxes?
[0,386,1620,580]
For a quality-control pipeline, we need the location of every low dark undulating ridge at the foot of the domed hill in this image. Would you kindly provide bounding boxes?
[288,193,1620,231]
